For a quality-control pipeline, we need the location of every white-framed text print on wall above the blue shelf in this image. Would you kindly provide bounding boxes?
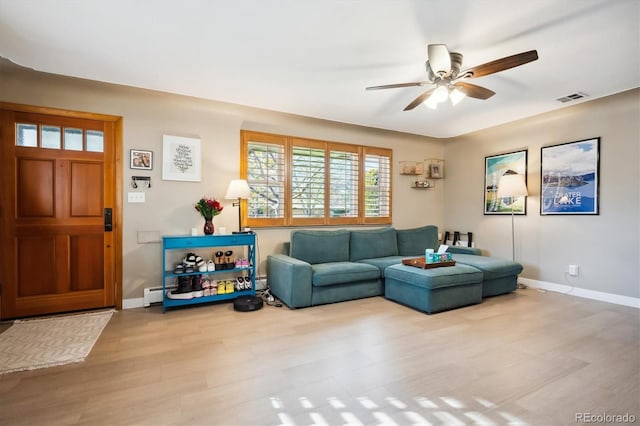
[162,135,201,182]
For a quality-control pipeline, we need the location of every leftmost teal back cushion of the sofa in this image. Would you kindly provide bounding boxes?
[291,229,350,264]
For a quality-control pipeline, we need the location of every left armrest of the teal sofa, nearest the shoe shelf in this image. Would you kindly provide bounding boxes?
[267,254,311,308]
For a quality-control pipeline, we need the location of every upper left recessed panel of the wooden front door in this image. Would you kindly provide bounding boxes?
[16,158,55,218]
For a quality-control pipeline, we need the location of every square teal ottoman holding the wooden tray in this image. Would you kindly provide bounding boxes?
[384,264,482,314]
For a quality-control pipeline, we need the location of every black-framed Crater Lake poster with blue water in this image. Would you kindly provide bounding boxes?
[540,138,600,215]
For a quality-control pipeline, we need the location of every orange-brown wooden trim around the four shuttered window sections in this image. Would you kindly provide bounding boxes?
[240,130,393,228]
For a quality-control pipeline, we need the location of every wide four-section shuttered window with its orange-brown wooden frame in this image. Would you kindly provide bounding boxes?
[241,131,392,227]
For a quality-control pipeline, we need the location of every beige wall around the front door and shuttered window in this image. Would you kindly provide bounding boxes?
[0,60,444,299]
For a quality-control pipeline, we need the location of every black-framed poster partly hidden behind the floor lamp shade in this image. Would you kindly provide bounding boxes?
[484,149,527,215]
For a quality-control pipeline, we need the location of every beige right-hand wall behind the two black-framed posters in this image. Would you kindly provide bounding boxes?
[444,89,640,298]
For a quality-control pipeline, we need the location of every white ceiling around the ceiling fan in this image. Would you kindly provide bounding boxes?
[0,0,640,137]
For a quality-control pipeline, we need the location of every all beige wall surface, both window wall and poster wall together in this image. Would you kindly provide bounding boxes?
[0,60,640,299]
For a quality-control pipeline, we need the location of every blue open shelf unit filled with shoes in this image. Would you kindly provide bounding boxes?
[162,234,256,312]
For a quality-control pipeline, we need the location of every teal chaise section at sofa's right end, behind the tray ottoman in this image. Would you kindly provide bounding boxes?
[452,253,522,297]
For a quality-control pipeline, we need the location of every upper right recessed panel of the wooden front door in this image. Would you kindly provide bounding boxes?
[69,161,104,220]
